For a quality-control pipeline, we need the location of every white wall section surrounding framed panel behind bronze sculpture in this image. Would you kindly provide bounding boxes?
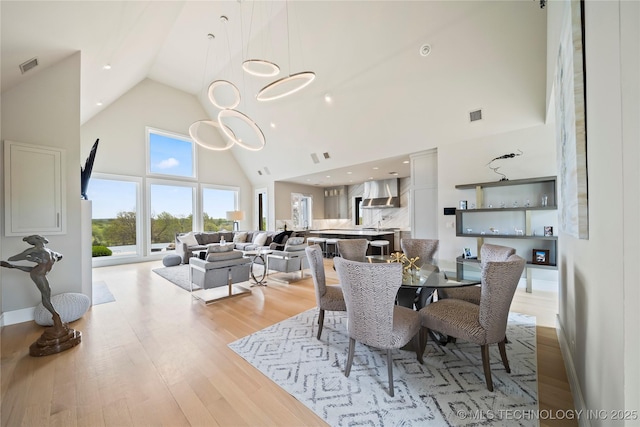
[0,53,82,323]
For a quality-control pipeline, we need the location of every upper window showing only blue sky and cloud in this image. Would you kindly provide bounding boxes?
[147,128,196,178]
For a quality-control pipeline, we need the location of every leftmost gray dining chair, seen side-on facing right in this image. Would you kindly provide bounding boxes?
[305,245,347,339]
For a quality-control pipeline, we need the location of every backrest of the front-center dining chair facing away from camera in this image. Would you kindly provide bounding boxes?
[333,257,402,348]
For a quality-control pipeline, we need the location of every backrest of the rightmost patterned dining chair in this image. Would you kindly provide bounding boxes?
[479,255,525,344]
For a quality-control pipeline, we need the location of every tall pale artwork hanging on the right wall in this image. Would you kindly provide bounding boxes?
[555,0,589,239]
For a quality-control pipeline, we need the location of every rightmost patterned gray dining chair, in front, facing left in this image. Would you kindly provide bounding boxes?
[420,255,525,391]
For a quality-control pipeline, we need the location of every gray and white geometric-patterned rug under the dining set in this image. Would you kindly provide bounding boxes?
[229,308,538,426]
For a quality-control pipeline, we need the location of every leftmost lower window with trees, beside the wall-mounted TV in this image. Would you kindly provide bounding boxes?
[87,174,141,258]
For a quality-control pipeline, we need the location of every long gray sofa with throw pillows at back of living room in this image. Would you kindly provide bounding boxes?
[175,230,295,264]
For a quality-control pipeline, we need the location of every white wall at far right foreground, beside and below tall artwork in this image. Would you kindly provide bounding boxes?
[551,1,640,425]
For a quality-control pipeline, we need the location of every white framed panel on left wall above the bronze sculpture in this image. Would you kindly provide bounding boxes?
[4,141,66,236]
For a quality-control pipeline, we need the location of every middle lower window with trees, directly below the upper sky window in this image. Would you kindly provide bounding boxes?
[148,182,195,252]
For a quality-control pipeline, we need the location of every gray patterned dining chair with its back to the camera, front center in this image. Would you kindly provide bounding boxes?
[334,257,422,396]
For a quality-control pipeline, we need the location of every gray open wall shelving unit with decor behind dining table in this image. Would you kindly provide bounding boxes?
[456,176,558,292]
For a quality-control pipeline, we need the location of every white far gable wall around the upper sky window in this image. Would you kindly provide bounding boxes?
[81,79,255,242]
